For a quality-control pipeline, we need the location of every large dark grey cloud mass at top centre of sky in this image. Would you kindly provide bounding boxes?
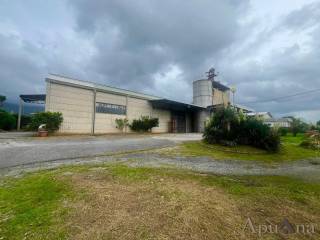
[70,0,248,97]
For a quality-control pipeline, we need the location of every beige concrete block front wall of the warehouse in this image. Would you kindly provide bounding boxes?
[45,82,171,133]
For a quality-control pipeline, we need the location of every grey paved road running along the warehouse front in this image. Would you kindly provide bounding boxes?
[0,134,192,168]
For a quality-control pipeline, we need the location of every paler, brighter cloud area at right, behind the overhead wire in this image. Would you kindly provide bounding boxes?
[215,3,320,118]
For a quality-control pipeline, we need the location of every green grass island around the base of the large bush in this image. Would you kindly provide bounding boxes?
[172,135,320,163]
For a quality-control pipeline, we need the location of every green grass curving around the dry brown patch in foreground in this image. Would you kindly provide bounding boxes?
[0,164,320,239]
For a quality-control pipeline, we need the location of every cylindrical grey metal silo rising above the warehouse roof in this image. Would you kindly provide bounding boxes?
[193,79,212,107]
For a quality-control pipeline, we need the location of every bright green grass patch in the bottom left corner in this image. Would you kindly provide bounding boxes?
[0,172,71,239]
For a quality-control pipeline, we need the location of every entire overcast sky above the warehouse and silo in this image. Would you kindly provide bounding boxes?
[0,0,320,121]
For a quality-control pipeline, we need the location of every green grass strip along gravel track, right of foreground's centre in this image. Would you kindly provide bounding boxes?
[82,164,320,207]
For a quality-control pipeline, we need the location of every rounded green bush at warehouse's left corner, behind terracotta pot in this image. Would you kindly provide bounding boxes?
[30,112,63,132]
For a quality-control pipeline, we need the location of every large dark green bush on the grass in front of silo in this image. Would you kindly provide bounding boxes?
[203,108,280,152]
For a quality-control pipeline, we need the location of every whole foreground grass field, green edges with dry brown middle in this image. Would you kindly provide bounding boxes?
[0,165,320,239]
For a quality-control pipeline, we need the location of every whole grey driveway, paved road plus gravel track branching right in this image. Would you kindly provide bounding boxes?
[0,133,320,181]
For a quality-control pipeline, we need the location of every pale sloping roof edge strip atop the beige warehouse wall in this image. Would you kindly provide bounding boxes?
[46,74,162,100]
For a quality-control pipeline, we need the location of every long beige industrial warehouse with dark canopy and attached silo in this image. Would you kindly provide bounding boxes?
[28,74,244,134]
